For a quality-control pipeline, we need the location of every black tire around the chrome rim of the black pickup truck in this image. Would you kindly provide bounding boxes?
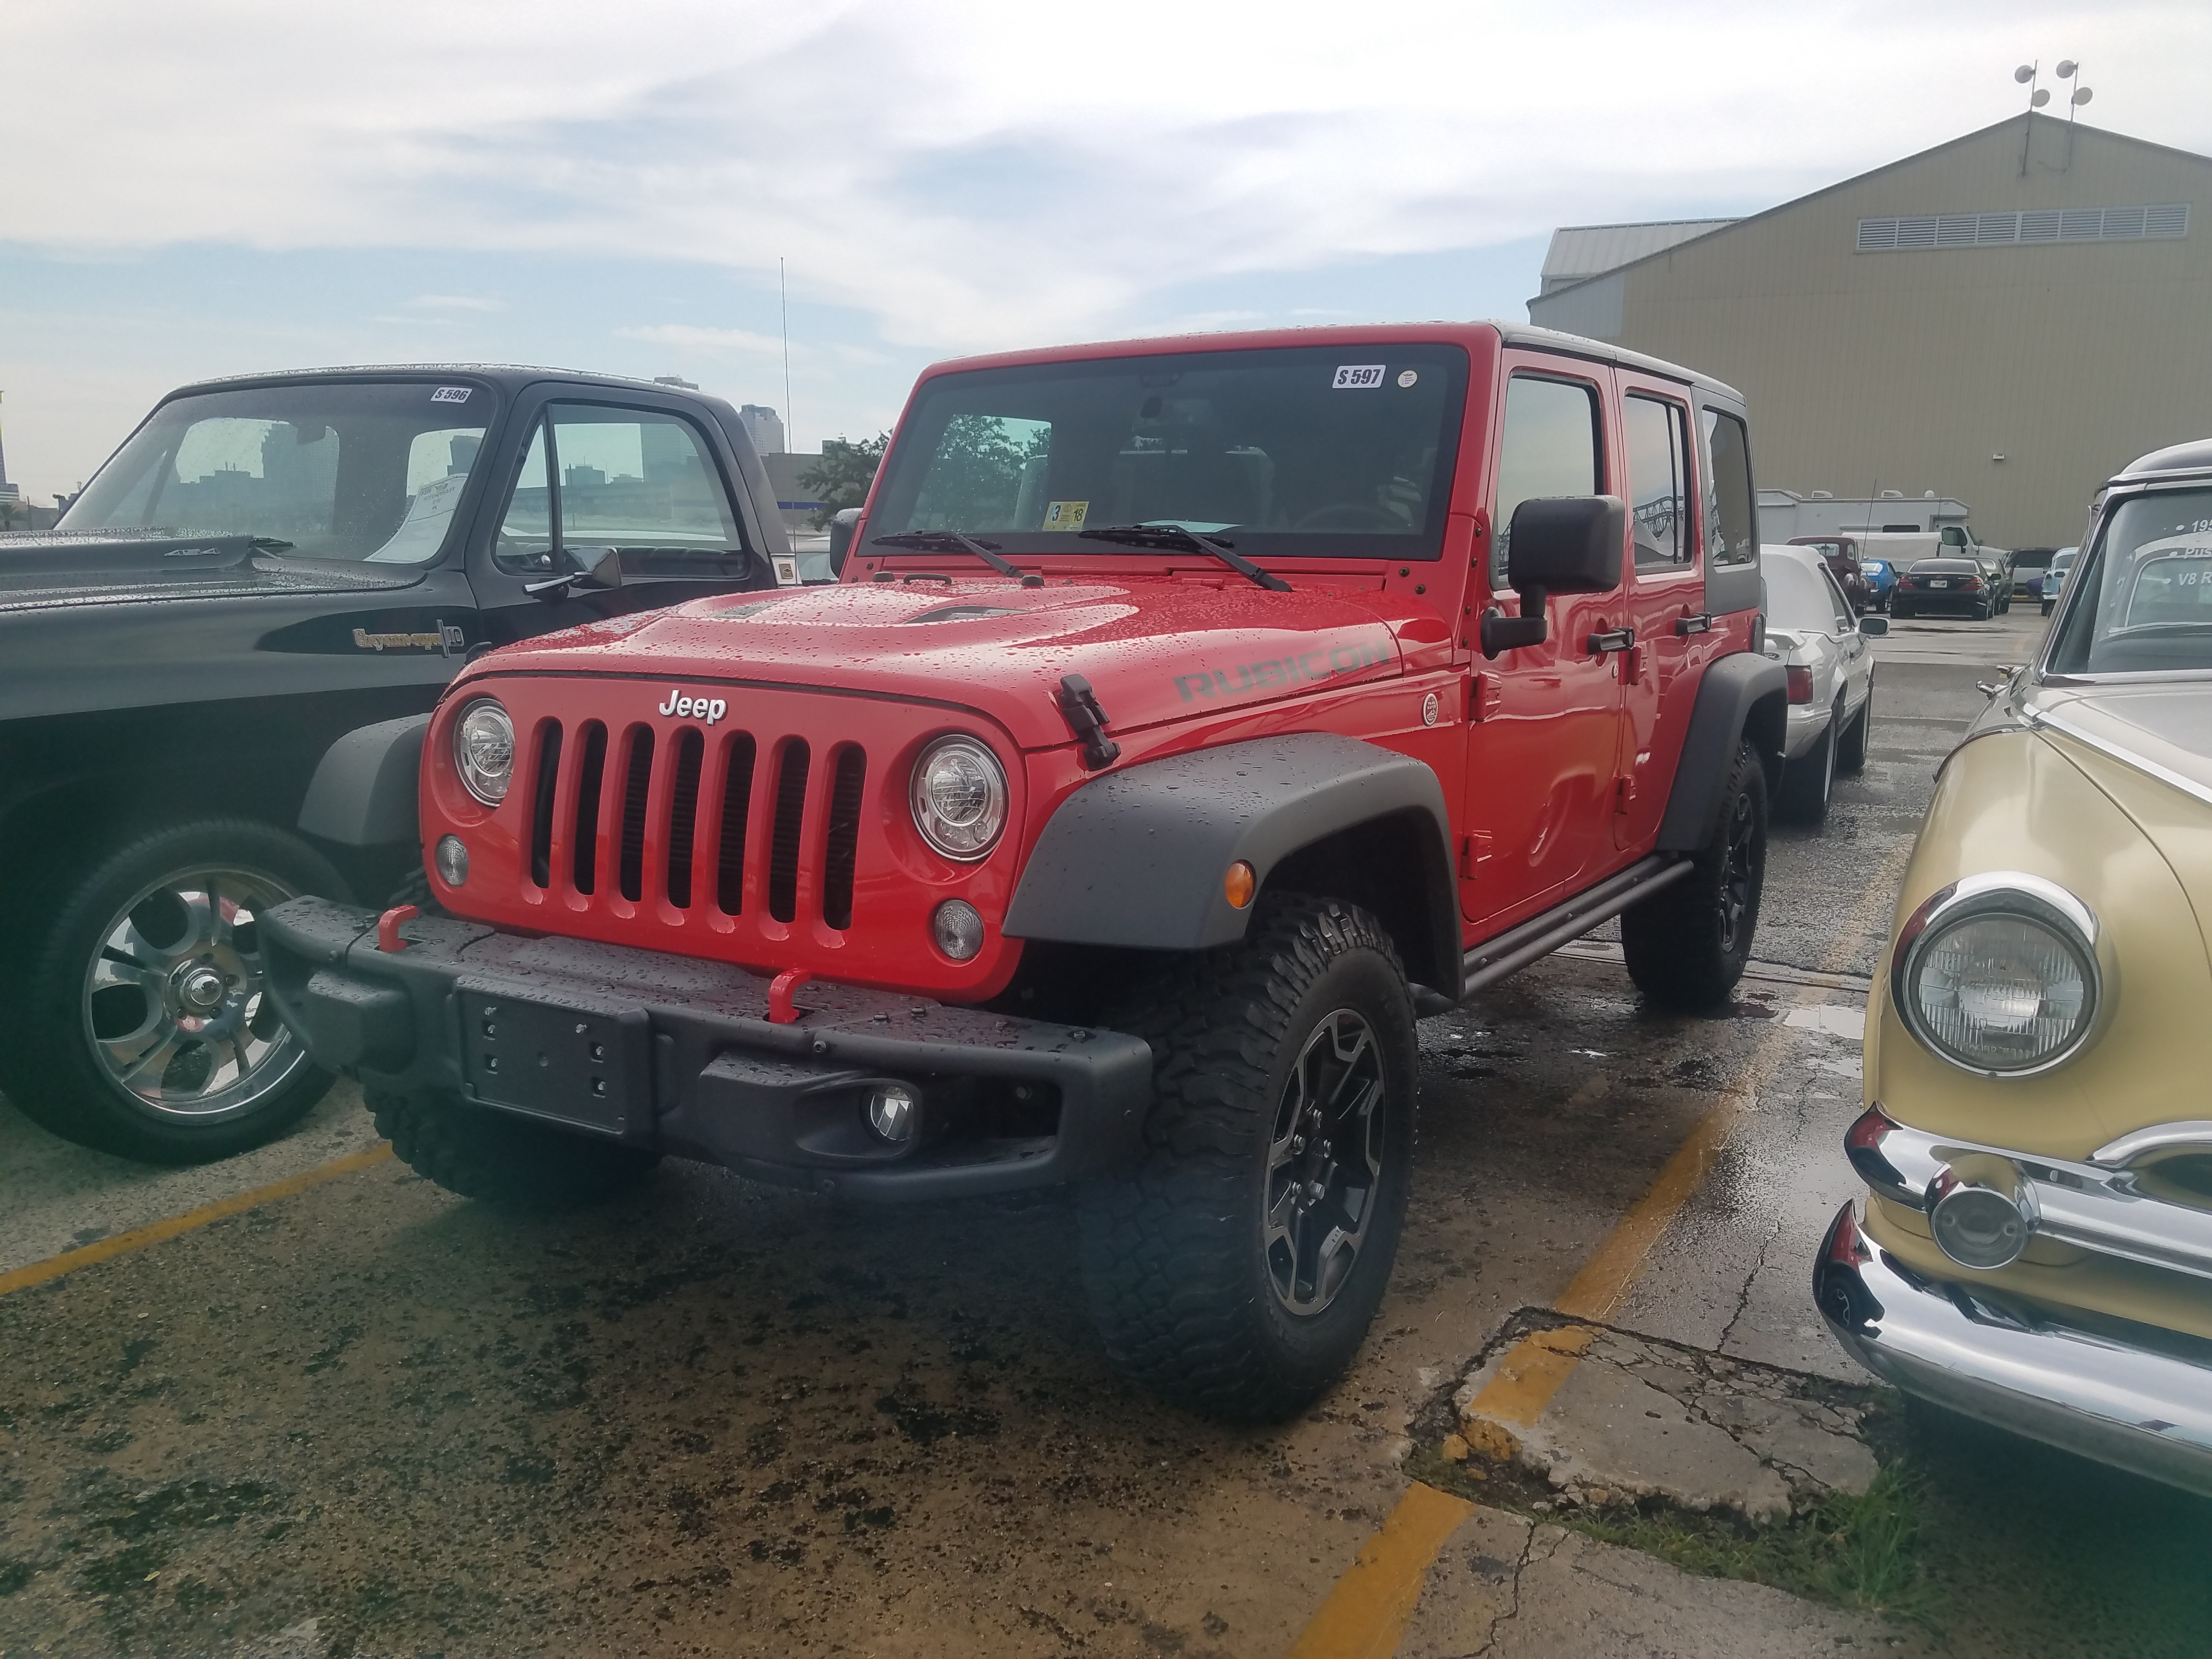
[0,819,347,1164]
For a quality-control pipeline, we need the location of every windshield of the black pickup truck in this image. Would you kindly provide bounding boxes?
[58,381,491,564]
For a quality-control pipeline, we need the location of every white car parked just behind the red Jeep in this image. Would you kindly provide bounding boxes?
[1758,546,1889,823]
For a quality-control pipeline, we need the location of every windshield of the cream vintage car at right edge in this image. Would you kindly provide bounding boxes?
[2051,489,2212,675]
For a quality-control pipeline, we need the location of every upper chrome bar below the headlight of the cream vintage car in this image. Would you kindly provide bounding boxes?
[1843,1106,2212,1278]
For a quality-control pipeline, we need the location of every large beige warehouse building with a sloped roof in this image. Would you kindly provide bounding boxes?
[1528,115,2212,546]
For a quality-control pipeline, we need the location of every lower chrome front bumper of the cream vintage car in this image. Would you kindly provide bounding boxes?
[1812,1203,2212,1498]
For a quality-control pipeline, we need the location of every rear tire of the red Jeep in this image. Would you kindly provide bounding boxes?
[1621,743,1768,1011]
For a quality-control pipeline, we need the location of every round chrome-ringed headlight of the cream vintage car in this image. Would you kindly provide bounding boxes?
[1889,872,2103,1077]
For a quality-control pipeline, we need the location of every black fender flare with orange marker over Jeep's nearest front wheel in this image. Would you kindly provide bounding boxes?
[1005,732,1460,1000]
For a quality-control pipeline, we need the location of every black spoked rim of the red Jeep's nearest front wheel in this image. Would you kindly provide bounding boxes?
[1265,1009,1389,1316]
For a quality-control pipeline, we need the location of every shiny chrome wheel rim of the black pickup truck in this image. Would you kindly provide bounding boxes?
[82,867,307,1121]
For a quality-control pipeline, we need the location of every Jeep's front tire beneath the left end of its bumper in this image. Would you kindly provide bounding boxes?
[367,1088,662,1210]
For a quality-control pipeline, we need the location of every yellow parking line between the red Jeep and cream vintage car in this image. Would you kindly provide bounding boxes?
[1288,843,1911,1659]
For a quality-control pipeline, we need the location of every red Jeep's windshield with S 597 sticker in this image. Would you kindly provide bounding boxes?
[865,345,1466,560]
